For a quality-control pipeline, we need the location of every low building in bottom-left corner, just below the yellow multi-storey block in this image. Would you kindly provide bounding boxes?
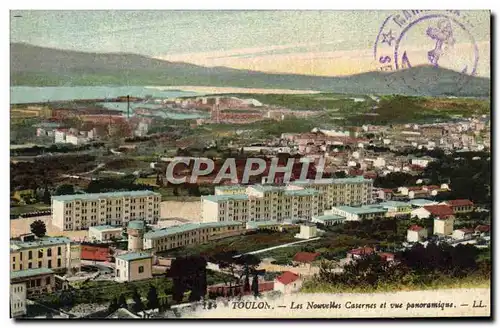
[10,268,56,297]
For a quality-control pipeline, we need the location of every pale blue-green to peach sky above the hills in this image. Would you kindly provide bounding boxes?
[11,11,490,77]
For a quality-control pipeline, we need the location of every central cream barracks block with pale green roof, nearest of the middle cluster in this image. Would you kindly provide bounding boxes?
[202,185,322,222]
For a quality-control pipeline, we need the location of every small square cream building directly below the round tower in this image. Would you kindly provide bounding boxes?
[115,252,153,282]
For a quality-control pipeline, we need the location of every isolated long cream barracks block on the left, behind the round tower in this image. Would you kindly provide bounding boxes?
[52,190,161,230]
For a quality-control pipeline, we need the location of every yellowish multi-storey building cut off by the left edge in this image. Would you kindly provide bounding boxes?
[10,237,81,272]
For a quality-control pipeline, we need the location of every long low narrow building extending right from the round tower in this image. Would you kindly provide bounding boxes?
[144,221,246,252]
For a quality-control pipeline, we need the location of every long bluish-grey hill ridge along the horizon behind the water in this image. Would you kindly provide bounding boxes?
[10,43,490,96]
